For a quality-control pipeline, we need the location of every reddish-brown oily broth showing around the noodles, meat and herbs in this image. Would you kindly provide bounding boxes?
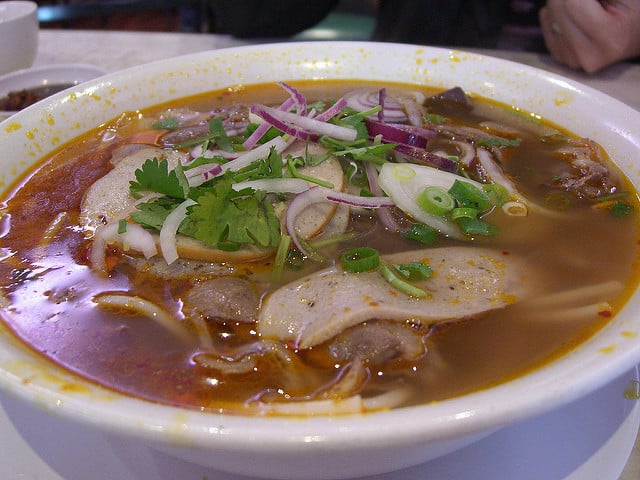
[0,82,638,411]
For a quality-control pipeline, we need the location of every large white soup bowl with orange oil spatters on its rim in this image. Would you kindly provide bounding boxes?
[0,42,640,479]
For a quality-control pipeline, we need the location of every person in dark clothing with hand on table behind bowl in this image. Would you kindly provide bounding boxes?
[211,0,640,72]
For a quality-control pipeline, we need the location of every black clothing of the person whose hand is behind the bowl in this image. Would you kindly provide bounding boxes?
[212,0,545,50]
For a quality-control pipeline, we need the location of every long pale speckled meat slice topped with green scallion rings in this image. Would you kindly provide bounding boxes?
[258,247,530,348]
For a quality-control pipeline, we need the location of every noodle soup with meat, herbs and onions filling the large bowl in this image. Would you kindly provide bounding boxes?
[0,82,638,414]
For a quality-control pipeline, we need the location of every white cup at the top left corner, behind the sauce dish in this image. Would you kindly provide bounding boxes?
[0,1,39,74]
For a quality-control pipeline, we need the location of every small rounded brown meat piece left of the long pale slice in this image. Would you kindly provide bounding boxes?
[184,277,259,323]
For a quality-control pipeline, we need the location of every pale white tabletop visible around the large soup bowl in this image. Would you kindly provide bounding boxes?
[6,30,640,480]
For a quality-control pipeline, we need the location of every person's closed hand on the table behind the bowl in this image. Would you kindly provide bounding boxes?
[539,0,640,73]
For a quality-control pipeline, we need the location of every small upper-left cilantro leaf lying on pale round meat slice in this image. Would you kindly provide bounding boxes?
[129,157,189,200]
